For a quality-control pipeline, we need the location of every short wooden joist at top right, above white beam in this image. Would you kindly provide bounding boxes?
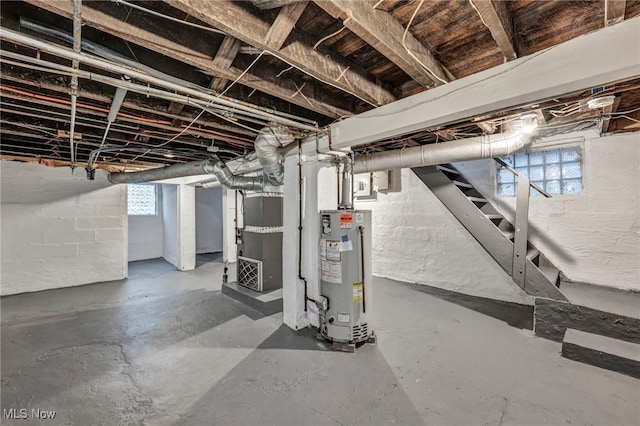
[469,0,518,61]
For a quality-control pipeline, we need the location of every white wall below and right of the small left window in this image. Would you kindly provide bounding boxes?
[129,186,164,262]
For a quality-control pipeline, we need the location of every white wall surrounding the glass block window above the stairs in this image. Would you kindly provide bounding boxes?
[457,132,640,291]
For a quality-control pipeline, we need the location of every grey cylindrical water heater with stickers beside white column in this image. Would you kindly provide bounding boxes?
[319,210,374,351]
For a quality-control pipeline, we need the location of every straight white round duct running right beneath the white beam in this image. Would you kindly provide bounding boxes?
[353,133,529,174]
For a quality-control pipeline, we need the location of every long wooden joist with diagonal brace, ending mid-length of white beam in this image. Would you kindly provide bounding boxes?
[167,0,395,105]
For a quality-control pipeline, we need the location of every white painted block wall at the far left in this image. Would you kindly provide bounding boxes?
[0,161,127,296]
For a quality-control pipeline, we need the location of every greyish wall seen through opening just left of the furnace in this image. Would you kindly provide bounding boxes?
[196,188,223,253]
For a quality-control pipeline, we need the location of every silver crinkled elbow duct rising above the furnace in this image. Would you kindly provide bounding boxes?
[255,127,294,186]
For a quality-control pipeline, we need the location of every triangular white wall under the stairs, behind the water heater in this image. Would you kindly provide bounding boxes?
[356,169,531,304]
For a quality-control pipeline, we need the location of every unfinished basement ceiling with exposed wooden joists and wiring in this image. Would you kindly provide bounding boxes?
[0,0,640,170]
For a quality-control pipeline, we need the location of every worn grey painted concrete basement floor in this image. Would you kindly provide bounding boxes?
[1,257,640,425]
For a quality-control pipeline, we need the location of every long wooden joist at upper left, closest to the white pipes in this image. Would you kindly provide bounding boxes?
[27,0,355,118]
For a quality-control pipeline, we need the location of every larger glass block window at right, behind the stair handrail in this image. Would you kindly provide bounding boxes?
[496,147,583,197]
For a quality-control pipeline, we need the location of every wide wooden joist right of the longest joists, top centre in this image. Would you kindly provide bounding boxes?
[315,0,453,87]
